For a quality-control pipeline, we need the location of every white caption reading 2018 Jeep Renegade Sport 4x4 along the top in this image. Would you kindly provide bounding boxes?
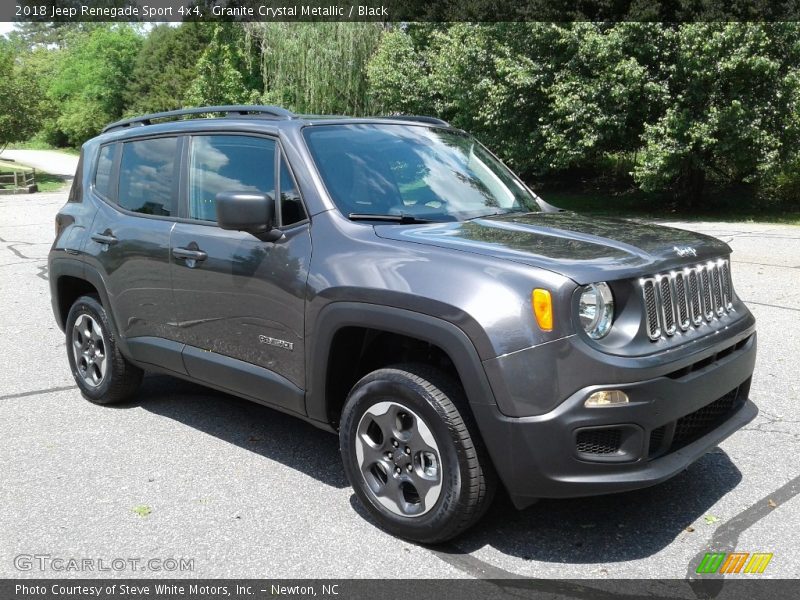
[15,4,389,21]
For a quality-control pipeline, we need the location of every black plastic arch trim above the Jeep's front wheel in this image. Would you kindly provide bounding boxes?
[306,302,496,423]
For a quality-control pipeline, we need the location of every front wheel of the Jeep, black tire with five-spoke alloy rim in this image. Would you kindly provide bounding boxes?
[339,364,496,544]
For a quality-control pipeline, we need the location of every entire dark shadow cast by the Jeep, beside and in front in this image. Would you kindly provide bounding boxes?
[119,375,742,564]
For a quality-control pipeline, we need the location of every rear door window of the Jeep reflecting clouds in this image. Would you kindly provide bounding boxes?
[117,137,178,216]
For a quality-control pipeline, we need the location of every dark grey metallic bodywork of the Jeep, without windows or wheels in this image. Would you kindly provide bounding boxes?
[50,111,755,506]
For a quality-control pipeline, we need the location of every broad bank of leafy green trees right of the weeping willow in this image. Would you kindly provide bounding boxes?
[367,22,800,205]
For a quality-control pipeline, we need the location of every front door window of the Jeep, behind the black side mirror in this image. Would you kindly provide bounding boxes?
[189,135,275,221]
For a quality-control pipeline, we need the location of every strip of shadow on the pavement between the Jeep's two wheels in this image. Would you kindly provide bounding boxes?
[119,374,349,489]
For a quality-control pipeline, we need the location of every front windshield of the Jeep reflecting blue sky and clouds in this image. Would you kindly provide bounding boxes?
[304,124,539,221]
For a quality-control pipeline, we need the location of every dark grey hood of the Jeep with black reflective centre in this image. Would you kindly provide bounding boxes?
[375,212,730,284]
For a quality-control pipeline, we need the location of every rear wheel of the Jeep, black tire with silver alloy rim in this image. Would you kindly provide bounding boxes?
[66,296,144,404]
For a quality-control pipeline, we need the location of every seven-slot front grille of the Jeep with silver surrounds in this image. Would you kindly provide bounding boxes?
[639,258,733,341]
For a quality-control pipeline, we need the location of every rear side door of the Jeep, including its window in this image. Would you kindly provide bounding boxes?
[85,136,182,358]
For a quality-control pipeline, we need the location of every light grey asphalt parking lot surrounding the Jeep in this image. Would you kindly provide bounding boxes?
[0,193,800,578]
